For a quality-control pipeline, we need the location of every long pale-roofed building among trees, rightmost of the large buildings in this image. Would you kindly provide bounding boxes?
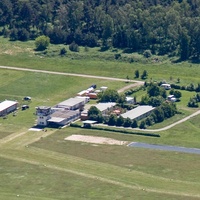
[121,106,155,120]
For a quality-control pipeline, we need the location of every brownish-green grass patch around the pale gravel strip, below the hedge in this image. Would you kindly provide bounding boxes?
[32,128,200,182]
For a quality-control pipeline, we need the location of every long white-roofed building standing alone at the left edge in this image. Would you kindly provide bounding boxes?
[0,100,18,116]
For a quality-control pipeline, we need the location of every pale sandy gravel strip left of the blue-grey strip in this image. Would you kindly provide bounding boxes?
[65,135,128,145]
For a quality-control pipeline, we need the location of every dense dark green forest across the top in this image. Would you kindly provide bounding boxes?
[0,0,200,60]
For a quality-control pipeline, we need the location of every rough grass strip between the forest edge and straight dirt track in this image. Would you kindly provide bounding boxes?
[0,37,200,85]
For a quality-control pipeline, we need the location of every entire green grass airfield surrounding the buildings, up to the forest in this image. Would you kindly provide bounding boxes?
[0,38,200,200]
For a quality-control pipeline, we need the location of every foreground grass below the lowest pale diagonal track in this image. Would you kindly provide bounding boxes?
[0,156,198,200]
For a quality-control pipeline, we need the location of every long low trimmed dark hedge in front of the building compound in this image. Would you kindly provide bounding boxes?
[70,124,160,137]
